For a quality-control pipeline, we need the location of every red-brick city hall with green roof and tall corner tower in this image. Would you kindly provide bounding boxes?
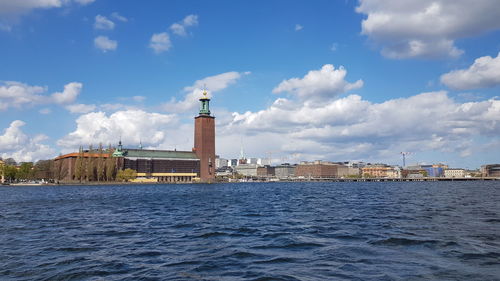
[54,91,215,182]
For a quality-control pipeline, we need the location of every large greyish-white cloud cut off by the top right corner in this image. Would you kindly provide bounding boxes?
[356,0,500,59]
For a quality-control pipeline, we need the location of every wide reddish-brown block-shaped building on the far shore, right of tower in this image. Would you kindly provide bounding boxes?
[295,160,348,178]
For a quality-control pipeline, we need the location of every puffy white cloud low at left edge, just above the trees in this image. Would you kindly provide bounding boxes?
[0,120,55,162]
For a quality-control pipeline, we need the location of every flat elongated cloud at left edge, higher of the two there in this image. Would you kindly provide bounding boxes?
[0,81,83,110]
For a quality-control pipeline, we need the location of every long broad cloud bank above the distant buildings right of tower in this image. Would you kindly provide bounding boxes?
[223,91,500,161]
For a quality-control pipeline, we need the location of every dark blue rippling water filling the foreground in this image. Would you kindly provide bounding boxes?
[0,182,500,280]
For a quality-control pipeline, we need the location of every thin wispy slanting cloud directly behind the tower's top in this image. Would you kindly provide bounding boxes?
[164,71,250,113]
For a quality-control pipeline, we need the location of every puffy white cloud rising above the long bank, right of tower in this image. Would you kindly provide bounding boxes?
[273,64,363,102]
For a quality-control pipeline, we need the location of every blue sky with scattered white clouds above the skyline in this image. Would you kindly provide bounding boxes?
[0,0,500,169]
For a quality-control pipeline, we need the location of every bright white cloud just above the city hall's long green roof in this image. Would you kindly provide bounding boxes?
[57,109,178,151]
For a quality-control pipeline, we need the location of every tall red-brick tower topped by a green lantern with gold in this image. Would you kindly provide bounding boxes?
[194,91,215,182]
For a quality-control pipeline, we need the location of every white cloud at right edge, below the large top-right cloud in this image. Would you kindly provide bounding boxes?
[441,53,500,90]
